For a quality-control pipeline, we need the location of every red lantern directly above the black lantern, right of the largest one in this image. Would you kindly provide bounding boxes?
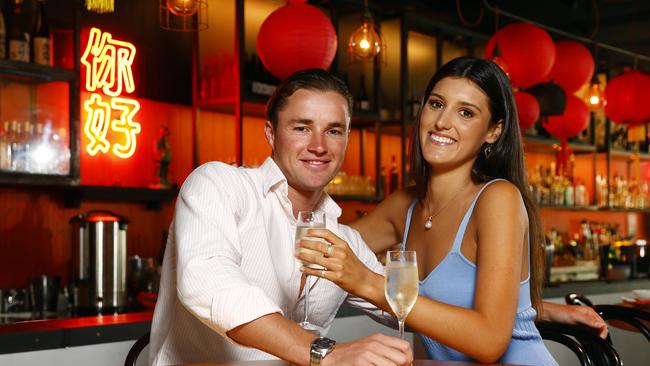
[549,41,594,93]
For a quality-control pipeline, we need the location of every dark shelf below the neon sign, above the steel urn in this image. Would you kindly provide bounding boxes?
[63,186,178,210]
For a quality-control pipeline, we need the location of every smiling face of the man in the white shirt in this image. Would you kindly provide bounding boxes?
[265,89,350,192]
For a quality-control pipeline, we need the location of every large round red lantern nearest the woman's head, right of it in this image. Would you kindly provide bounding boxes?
[485,23,555,88]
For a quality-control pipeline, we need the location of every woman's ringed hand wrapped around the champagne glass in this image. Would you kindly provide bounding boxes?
[296,229,384,302]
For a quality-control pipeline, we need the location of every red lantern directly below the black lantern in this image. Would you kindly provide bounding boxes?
[544,94,589,139]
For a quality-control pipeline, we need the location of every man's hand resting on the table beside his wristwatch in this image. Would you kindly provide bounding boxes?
[322,334,413,366]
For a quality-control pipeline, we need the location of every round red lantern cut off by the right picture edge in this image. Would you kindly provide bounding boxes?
[605,70,650,125]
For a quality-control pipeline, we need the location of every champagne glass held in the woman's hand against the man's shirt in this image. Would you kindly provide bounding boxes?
[295,211,325,334]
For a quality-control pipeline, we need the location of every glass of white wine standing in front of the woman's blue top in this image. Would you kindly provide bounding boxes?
[384,250,419,339]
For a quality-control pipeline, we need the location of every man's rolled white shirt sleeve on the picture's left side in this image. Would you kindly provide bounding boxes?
[174,163,282,340]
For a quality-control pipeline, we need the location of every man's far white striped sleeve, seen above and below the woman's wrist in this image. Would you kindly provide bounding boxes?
[340,225,397,328]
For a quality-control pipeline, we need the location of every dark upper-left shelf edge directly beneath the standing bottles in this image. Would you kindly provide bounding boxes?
[0,60,77,83]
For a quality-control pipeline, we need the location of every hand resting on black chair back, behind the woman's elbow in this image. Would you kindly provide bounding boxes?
[542,302,609,339]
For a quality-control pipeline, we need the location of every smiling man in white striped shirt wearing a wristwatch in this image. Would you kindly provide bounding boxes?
[150,69,412,366]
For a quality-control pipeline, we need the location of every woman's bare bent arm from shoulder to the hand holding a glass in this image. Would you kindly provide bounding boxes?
[300,182,528,363]
